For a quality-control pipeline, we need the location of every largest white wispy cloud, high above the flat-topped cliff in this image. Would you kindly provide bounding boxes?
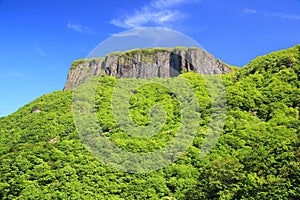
[110,0,201,28]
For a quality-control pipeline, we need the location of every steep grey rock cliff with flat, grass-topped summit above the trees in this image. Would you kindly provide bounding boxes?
[64,47,231,90]
